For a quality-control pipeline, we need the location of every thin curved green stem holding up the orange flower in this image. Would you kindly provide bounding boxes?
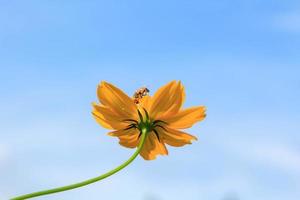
[11,129,147,200]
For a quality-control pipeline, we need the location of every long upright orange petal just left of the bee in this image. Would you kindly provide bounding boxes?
[97,81,137,119]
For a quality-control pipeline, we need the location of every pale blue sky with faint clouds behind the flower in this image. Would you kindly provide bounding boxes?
[0,0,300,200]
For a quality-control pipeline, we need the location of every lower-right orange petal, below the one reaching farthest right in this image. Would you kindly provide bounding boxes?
[158,127,197,147]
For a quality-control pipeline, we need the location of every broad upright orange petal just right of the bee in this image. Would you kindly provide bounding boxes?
[150,81,185,118]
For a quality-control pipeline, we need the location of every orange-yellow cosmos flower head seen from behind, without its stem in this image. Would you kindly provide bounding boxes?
[92,81,206,160]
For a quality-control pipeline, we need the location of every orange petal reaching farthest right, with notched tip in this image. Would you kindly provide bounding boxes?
[160,106,206,129]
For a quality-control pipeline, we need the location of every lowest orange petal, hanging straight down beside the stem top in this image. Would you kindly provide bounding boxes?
[140,132,168,160]
